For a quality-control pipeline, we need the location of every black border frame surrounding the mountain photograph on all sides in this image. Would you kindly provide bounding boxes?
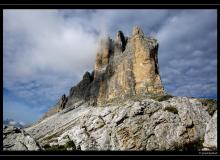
[0,4,220,159]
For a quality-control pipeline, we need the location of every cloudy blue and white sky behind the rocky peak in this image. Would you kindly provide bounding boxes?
[3,9,217,124]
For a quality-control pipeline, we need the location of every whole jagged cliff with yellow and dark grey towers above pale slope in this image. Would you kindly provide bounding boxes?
[62,27,165,107]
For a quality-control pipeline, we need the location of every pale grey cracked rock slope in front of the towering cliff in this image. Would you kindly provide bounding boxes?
[9,97,214,151]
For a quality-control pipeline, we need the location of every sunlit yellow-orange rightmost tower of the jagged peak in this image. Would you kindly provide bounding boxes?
[131,27,164,94]
